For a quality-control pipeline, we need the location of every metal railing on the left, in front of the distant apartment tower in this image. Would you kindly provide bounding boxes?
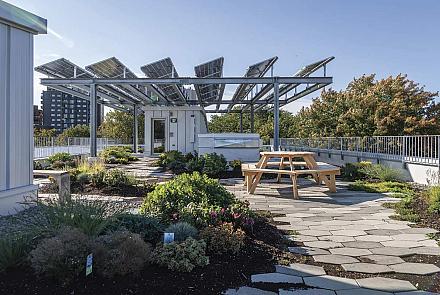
[34,137,143,159]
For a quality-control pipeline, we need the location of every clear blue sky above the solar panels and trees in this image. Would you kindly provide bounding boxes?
[7,0,440,112]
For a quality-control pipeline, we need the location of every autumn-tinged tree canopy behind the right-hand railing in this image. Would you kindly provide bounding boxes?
[209,75,440,141]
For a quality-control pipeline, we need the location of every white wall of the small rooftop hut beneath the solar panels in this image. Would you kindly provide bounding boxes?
[143,106,208,156]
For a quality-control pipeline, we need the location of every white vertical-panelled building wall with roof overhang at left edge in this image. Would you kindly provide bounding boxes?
[0,1,46,215]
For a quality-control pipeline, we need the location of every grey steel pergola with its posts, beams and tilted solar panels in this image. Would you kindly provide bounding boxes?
[35,57,334,157]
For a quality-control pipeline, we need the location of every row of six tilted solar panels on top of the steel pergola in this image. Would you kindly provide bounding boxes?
[35,56,334,112]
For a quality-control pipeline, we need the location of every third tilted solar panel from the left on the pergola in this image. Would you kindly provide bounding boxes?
[141,57,186,104]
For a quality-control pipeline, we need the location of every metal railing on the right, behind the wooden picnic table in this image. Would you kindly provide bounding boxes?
[271,135,440,167]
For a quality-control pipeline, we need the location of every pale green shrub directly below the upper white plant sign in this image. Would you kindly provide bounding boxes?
[153,238,209,272]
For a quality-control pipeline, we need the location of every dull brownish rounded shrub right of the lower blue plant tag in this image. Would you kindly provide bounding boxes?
[93,231,152,278]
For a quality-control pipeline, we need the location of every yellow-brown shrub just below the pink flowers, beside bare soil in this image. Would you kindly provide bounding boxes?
[200,223,246,254]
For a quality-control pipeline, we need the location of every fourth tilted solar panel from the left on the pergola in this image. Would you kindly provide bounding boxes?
[194,57,225,105]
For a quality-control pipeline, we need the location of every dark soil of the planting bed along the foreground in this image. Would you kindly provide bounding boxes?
[0,214,304,295]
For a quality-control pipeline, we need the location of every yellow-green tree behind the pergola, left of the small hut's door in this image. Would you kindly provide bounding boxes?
[99,110,144,142]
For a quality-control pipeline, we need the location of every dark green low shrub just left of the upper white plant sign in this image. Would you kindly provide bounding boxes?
[117,214,165,244]
